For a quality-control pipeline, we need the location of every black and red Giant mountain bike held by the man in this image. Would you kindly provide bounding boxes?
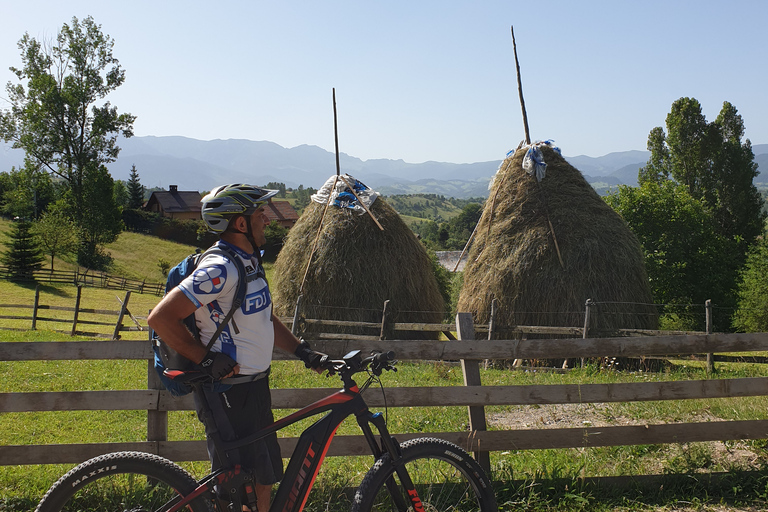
[37,350,497,512]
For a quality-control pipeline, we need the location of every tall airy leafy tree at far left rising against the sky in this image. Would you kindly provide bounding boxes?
[0,16,135,263]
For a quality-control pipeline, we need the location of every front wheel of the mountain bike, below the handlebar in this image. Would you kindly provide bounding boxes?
[352,437,498,512]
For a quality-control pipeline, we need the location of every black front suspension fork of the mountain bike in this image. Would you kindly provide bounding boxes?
[358,412,424,512]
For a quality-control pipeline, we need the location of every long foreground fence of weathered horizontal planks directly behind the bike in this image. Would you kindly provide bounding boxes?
[0,313,768,478]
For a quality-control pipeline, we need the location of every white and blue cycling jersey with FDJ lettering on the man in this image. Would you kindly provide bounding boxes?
[179,240,275,375]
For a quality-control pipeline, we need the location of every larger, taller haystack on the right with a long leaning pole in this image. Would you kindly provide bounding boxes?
[458,144,658,337]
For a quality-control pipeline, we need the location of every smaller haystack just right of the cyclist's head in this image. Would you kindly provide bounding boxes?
[272,174,445,338]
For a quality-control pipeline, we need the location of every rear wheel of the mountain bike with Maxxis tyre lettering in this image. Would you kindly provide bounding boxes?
[36,452,211,512]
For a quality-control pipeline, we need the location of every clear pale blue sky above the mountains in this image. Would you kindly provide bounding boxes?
[0,0,768,163]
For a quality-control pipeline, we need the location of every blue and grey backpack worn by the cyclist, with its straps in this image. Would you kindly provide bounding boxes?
[152,245,246,396]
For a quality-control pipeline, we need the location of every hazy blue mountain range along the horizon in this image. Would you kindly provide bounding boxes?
[0,136,768,198]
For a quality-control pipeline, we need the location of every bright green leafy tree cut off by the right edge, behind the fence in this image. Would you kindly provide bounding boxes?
[733,231,768,332]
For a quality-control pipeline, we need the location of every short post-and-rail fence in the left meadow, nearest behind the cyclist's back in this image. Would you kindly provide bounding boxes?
[0,285,148,340]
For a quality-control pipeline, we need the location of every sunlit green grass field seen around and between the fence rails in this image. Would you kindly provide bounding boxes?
[0,227,768,512]
